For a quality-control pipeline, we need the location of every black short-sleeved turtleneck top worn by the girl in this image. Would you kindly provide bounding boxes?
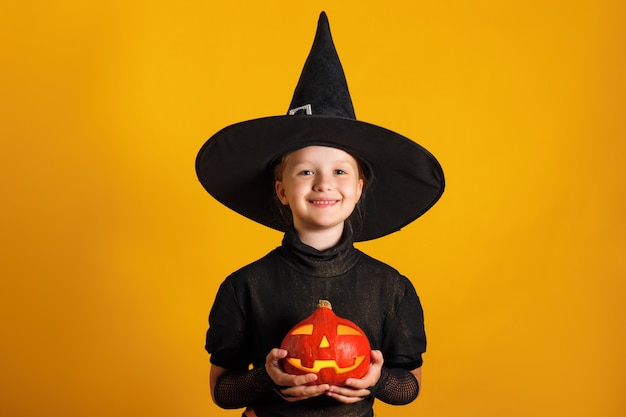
[206,228,426,417]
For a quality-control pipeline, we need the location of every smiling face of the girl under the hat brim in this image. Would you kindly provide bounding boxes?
[275,146,363,231]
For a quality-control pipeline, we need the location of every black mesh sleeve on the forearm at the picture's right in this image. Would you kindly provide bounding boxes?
[371,368,420,405]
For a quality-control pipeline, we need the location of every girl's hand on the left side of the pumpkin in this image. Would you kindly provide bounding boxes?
[265,349,330,402]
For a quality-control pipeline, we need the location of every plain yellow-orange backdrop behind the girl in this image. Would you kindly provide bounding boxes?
[0,0,626,417]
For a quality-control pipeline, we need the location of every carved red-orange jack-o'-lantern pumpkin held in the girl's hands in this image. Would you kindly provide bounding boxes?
[280,300,370,386]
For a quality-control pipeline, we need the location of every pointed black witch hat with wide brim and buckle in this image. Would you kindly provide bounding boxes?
[196,12,444,241]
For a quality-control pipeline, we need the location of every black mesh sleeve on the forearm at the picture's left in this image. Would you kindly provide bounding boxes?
[213,366,274,408]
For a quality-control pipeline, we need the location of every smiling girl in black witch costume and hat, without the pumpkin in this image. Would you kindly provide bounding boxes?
[196,13,444,417]
